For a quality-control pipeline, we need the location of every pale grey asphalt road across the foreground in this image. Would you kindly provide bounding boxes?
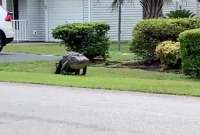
[0,83,200,135]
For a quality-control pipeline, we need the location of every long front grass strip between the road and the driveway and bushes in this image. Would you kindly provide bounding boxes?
[0,62,200,96]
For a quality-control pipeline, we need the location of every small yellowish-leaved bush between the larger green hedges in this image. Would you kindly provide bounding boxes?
[155,41,181,70]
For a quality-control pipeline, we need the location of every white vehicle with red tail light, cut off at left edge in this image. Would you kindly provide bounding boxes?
[0,6,14,51]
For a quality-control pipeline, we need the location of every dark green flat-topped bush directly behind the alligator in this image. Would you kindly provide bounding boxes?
[52,23,109,59]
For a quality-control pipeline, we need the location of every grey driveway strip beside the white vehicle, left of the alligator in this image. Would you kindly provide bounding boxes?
[0,52,61,63]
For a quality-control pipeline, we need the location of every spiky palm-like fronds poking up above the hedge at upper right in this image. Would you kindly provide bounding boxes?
[166,9,195,18]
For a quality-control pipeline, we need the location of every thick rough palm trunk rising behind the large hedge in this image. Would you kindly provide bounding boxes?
[140,0,164,19]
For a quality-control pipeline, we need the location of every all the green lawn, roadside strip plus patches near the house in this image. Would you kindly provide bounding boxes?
[0,43,200,96]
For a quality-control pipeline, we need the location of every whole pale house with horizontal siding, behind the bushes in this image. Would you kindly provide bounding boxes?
[0,0,199,41]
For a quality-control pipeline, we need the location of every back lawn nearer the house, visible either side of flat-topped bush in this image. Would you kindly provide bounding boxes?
[3,42,137,62]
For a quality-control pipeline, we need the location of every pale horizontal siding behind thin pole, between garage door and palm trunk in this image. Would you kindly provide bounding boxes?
[91,0,142,40]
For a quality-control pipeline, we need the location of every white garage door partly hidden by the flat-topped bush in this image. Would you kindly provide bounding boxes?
[47,0,85,41]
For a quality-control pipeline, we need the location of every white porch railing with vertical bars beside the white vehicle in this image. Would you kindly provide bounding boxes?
[12,20,27,42]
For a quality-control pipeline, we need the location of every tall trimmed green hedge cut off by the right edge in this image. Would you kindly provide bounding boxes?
[179,29,200,77]
